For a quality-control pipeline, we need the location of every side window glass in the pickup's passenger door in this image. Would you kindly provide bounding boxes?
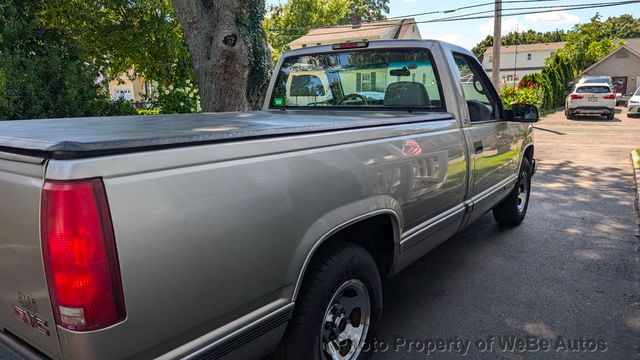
[453,54,498,122]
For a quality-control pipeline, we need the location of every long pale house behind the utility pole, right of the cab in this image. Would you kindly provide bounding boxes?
[482,42,564,83]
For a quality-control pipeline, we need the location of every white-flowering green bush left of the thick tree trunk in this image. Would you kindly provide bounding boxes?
[150,79,202,114]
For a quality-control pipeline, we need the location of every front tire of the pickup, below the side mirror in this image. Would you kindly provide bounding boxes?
[493,158,532,226]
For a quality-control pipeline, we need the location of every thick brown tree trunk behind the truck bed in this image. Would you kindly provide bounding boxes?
[171,0,270,112]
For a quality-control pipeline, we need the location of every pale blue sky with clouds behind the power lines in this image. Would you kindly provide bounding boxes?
[267,0,640,49]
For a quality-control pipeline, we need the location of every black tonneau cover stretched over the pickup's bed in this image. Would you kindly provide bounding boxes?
[0,110,451,159]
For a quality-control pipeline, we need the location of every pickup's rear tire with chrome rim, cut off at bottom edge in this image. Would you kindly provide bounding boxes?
[275,242,382,360]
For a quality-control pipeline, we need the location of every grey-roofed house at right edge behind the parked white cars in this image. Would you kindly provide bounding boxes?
[580,39,640,95]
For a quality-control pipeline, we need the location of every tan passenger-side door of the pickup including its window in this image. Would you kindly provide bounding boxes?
[454,54,520,220]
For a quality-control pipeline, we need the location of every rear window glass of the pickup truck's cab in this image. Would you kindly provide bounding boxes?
[271,49,444,111]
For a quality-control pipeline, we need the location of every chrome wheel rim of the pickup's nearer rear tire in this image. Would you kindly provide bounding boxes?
[320,280,371,360]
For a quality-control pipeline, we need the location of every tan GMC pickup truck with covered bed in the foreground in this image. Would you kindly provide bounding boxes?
[0,40,538,360]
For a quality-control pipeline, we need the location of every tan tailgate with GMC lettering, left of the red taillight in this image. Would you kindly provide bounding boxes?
[0,153,62,358]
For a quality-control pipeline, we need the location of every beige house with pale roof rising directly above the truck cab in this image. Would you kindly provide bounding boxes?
[289,18,422,49]
